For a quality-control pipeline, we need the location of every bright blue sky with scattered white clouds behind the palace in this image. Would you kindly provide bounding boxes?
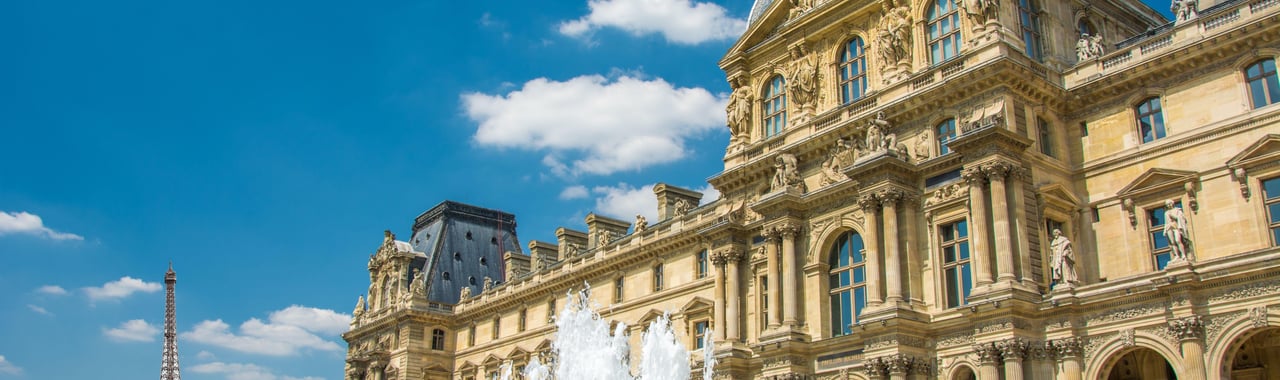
[0,0,1166,380]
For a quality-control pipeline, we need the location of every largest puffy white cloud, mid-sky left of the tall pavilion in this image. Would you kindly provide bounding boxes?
[462,74,724,175]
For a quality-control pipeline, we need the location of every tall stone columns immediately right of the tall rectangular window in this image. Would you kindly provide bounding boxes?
[960,161,1030,285]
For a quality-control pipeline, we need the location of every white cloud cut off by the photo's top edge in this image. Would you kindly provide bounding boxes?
[559,0,746,45]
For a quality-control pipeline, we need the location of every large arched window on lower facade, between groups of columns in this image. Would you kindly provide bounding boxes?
[827,232,867,336]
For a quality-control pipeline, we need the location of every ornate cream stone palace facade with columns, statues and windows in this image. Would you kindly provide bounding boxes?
[344,0,1280,380]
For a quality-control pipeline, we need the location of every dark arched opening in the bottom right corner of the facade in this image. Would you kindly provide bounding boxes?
[1220,328,1280,380]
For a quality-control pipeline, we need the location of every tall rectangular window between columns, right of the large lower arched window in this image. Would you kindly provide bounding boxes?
[936,218,974,308]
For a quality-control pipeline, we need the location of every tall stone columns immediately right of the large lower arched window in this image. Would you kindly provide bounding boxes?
[858,189,919,306]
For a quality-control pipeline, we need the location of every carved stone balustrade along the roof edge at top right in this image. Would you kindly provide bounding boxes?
[1062,0,1280,90]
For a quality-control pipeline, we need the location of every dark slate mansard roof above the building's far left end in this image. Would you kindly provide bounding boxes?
[410,201,524,303]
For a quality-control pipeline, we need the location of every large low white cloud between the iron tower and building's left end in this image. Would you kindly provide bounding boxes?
[182,306,351,356]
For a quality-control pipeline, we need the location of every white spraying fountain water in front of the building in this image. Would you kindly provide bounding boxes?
[499,284,716,380]
